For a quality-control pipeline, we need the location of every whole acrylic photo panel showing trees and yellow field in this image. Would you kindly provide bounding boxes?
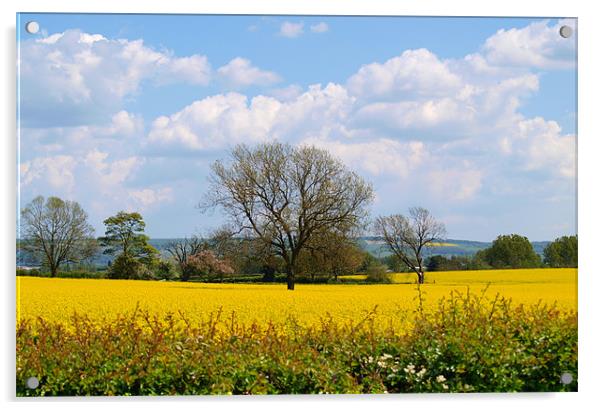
[16,13,578,396]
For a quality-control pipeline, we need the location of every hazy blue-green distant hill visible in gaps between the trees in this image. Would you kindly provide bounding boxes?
[17,236,550,267]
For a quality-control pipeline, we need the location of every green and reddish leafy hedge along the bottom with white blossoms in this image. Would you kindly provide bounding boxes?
[16,294,577,396]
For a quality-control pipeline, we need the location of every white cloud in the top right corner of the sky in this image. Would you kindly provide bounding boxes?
[483,19,576,69]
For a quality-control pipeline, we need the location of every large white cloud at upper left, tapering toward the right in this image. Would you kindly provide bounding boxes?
[19,30,211,126]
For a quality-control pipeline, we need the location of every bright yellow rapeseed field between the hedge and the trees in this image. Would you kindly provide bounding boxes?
[17,269,577,330]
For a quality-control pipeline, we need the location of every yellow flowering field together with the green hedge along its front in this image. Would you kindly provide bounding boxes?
[17,269,577,396]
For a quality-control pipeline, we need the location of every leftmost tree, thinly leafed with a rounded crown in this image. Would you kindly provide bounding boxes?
[21,196,98,277]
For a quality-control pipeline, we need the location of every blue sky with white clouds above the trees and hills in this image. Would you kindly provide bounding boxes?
[17,13,577,241]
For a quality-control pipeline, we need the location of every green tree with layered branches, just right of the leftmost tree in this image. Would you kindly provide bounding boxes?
[99,211,159,279]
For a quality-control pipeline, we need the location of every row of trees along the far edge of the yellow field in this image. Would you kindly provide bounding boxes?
[17,142,576,290]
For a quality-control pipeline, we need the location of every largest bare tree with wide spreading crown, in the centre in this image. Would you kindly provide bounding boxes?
[202,142,373,290]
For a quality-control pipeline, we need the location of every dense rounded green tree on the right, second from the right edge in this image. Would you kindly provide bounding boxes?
[477,234,541,269]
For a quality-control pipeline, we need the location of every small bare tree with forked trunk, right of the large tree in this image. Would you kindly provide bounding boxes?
[374,207,446,284]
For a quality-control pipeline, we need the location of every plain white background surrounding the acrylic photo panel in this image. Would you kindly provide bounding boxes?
[0,0,602,410]
